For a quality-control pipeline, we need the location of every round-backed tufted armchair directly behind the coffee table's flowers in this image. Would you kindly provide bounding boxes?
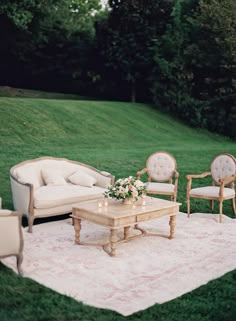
[137,151,179,201]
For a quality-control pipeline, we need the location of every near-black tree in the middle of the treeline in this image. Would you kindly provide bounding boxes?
[97,0,173,101]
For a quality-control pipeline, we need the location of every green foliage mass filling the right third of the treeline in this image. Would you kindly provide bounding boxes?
[151,0,236,136]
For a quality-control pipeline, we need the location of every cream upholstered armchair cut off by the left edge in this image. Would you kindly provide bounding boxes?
[0,209,24,275]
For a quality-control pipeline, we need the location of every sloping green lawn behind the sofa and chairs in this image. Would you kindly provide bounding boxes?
[0,91,236,216]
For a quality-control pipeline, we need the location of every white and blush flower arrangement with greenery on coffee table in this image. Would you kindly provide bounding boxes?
[104,176,147,201]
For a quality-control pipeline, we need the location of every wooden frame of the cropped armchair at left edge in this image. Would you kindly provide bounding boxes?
[0,209,24,275]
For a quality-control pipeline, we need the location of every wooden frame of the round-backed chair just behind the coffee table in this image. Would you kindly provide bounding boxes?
[137,151,179,202]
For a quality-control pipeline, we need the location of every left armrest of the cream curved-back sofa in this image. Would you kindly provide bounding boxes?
[10,175,34,216]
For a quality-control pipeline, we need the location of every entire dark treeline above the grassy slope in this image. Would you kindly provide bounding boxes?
[0,0,236,137]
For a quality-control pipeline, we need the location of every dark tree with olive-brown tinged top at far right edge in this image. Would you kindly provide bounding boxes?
[186,0,236,134]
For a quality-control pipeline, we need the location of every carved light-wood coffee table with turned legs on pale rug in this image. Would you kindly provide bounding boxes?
[71,197,181,256]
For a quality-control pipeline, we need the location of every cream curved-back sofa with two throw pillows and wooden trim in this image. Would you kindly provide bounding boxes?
[10,156,114,232]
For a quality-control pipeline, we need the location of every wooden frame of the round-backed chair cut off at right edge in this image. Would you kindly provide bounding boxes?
[186,153,236,223]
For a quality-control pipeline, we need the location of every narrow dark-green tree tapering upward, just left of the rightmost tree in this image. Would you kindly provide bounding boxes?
[151,0,198,126]
